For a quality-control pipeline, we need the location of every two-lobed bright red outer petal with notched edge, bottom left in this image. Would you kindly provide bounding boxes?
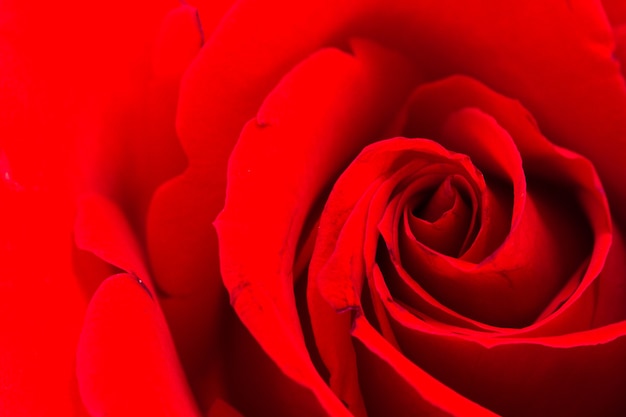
[76,195,199,416]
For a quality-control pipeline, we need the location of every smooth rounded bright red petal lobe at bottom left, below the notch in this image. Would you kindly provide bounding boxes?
[76,274,200,416]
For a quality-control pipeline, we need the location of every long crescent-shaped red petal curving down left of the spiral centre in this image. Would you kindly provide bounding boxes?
[215,42,410,412]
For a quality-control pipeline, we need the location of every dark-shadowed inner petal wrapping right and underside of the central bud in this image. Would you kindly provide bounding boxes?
[394,110,591,327]
